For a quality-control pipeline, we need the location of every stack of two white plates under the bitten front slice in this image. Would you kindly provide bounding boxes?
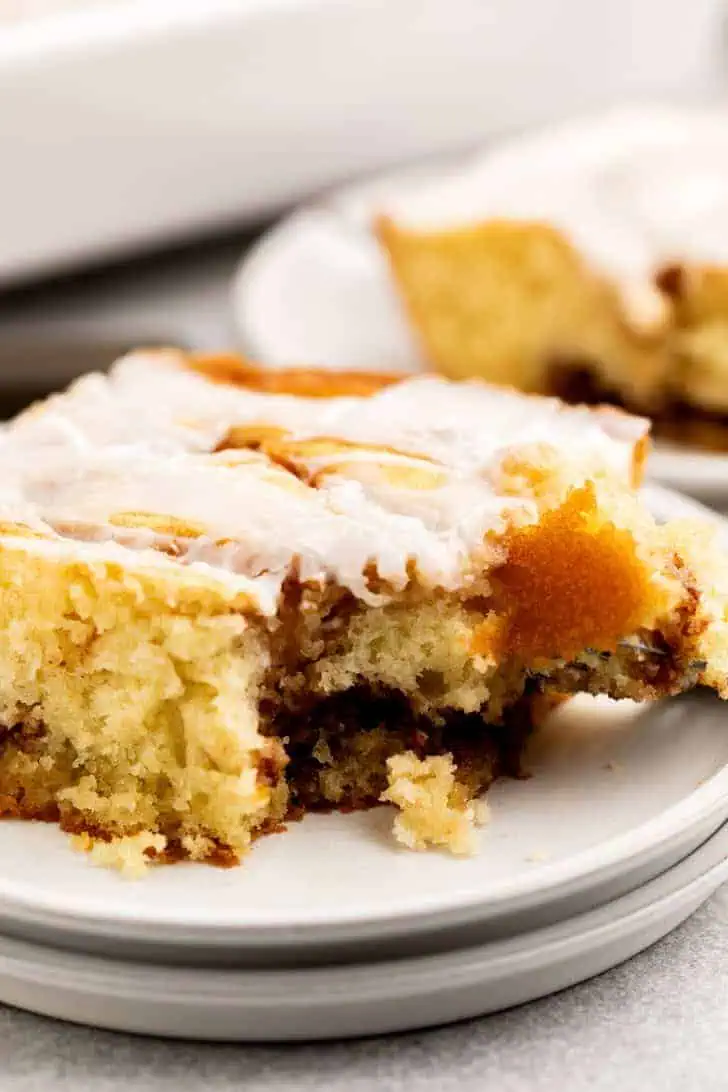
[0,489,728,1040]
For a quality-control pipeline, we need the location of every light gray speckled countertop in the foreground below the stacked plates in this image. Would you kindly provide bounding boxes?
[0,889,728,1092]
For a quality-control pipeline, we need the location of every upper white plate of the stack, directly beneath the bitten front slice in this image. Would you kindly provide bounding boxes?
[0,489,728,962]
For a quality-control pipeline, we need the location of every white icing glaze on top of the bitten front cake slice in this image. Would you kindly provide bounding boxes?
[0,352,646,612]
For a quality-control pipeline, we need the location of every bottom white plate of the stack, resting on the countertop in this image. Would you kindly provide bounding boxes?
[0,827,728,1041]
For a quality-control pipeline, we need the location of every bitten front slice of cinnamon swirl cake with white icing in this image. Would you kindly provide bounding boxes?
[0,351,728,869]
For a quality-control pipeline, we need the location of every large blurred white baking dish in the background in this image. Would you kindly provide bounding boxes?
[0,0,723,283]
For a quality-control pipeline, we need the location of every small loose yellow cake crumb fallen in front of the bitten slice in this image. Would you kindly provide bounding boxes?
[381,751,488,856]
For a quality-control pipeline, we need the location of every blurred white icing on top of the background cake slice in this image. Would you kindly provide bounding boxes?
[366,108,728,325]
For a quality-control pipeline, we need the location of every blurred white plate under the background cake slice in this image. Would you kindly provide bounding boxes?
[232,162,728,505]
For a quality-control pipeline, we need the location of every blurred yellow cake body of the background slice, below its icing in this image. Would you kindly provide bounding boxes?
[377,218,728,448]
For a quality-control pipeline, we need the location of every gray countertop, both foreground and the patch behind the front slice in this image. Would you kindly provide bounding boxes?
[0,237,728,1092]
